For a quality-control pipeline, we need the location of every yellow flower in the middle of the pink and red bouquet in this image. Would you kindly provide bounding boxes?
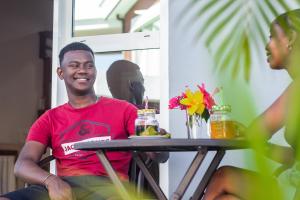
[180,89,205,115]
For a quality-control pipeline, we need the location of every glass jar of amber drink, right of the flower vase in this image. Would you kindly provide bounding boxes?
[209,105,236,139]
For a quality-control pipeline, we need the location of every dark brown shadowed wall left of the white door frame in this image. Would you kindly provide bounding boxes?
[0,0,53,144]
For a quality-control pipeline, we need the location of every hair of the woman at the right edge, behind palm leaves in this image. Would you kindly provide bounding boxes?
[270,9,300,36]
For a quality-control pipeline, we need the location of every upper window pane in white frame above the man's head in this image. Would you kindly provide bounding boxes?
[72,0,160,37]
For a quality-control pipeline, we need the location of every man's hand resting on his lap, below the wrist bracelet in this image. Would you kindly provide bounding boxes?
[45,175,75,200]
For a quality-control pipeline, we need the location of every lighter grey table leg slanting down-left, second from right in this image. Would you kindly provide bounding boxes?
[171,149,207,200]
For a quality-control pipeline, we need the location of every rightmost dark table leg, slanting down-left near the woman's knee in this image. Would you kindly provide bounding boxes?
[191,150,225,200]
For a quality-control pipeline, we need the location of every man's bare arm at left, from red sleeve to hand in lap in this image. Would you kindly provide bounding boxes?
[14,141,72,200]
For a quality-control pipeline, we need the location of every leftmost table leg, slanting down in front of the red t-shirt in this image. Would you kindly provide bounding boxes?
[96,150,131,200]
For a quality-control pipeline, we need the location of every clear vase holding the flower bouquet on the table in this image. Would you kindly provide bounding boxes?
[186,115,207,139]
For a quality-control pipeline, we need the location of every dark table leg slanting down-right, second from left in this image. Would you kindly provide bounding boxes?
[133,152,167,200]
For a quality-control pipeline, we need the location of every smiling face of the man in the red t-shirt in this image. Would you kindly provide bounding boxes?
[57,50,97,95]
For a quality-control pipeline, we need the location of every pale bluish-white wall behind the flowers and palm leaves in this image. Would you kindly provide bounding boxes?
[161,0,290,199]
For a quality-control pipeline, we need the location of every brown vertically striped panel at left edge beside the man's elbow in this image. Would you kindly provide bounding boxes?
[0,155,16,194]
